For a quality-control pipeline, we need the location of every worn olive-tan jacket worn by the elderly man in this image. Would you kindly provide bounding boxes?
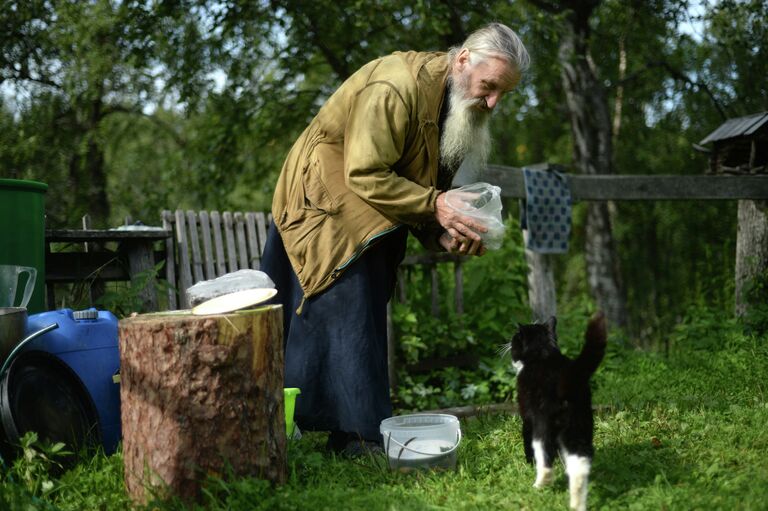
[272,52,448,298]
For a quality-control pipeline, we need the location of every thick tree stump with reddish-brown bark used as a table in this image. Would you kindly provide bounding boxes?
[119,305,286,502]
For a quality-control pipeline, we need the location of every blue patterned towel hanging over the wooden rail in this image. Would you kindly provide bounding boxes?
[520,167,571,254]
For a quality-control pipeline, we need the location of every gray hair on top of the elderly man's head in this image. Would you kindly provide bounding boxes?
[448,23,531,73]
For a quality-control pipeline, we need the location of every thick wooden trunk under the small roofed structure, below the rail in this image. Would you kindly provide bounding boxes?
[735,200,768,316]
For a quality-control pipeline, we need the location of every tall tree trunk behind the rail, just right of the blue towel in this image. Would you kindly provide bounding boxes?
[559,2,627,327]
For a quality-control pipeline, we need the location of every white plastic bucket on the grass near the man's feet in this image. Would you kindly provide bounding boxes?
[379,413,461,470]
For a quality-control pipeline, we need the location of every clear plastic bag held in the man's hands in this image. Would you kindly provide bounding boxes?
[445,183,504,250]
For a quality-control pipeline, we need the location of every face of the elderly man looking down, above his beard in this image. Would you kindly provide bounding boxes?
[453,49,520,111]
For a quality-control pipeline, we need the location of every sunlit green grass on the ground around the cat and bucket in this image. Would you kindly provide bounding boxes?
[0,323,768,511]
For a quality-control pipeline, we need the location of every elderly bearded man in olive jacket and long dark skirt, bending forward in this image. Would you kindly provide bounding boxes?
[262,23,529,456]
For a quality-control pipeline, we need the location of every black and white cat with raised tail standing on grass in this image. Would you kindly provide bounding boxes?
[506,313,606,511]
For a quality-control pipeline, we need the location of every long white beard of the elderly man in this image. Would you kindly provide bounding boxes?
[440,77,491,171]
